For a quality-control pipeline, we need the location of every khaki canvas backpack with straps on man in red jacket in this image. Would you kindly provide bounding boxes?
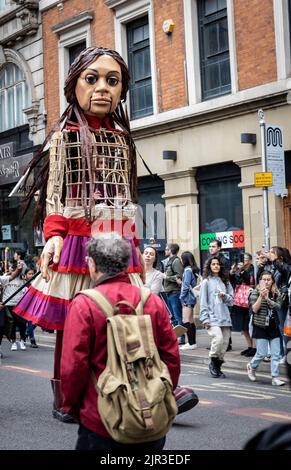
[80,287,177,444]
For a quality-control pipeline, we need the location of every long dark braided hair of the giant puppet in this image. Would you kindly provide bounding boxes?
[24,47,137,227]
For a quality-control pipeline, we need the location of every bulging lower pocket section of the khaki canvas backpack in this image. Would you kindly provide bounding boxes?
[98,374,177,443]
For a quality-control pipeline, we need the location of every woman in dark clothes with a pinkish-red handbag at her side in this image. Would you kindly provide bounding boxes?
[229,253,256,357]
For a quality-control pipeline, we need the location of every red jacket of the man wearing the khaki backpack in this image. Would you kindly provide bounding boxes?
[61,273,180,437]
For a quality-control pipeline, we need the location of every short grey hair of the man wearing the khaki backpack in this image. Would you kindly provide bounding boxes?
[86,232,131,275]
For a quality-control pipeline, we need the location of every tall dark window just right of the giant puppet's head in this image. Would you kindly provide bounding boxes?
[127,16,153,119]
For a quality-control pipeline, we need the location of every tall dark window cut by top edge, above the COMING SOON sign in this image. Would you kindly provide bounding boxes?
[198,0,231,100]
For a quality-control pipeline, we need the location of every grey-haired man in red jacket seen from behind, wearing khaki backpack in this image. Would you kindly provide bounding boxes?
[61,234,180,453]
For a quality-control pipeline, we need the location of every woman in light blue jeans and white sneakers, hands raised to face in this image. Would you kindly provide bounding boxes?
[247,271,285,386]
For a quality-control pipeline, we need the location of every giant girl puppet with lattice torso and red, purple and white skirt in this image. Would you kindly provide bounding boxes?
[15,47,142,421]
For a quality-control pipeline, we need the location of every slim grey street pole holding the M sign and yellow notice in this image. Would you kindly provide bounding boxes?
[258,109,270,251]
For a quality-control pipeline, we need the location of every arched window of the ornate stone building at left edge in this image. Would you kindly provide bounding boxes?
[0,63,29,132]
